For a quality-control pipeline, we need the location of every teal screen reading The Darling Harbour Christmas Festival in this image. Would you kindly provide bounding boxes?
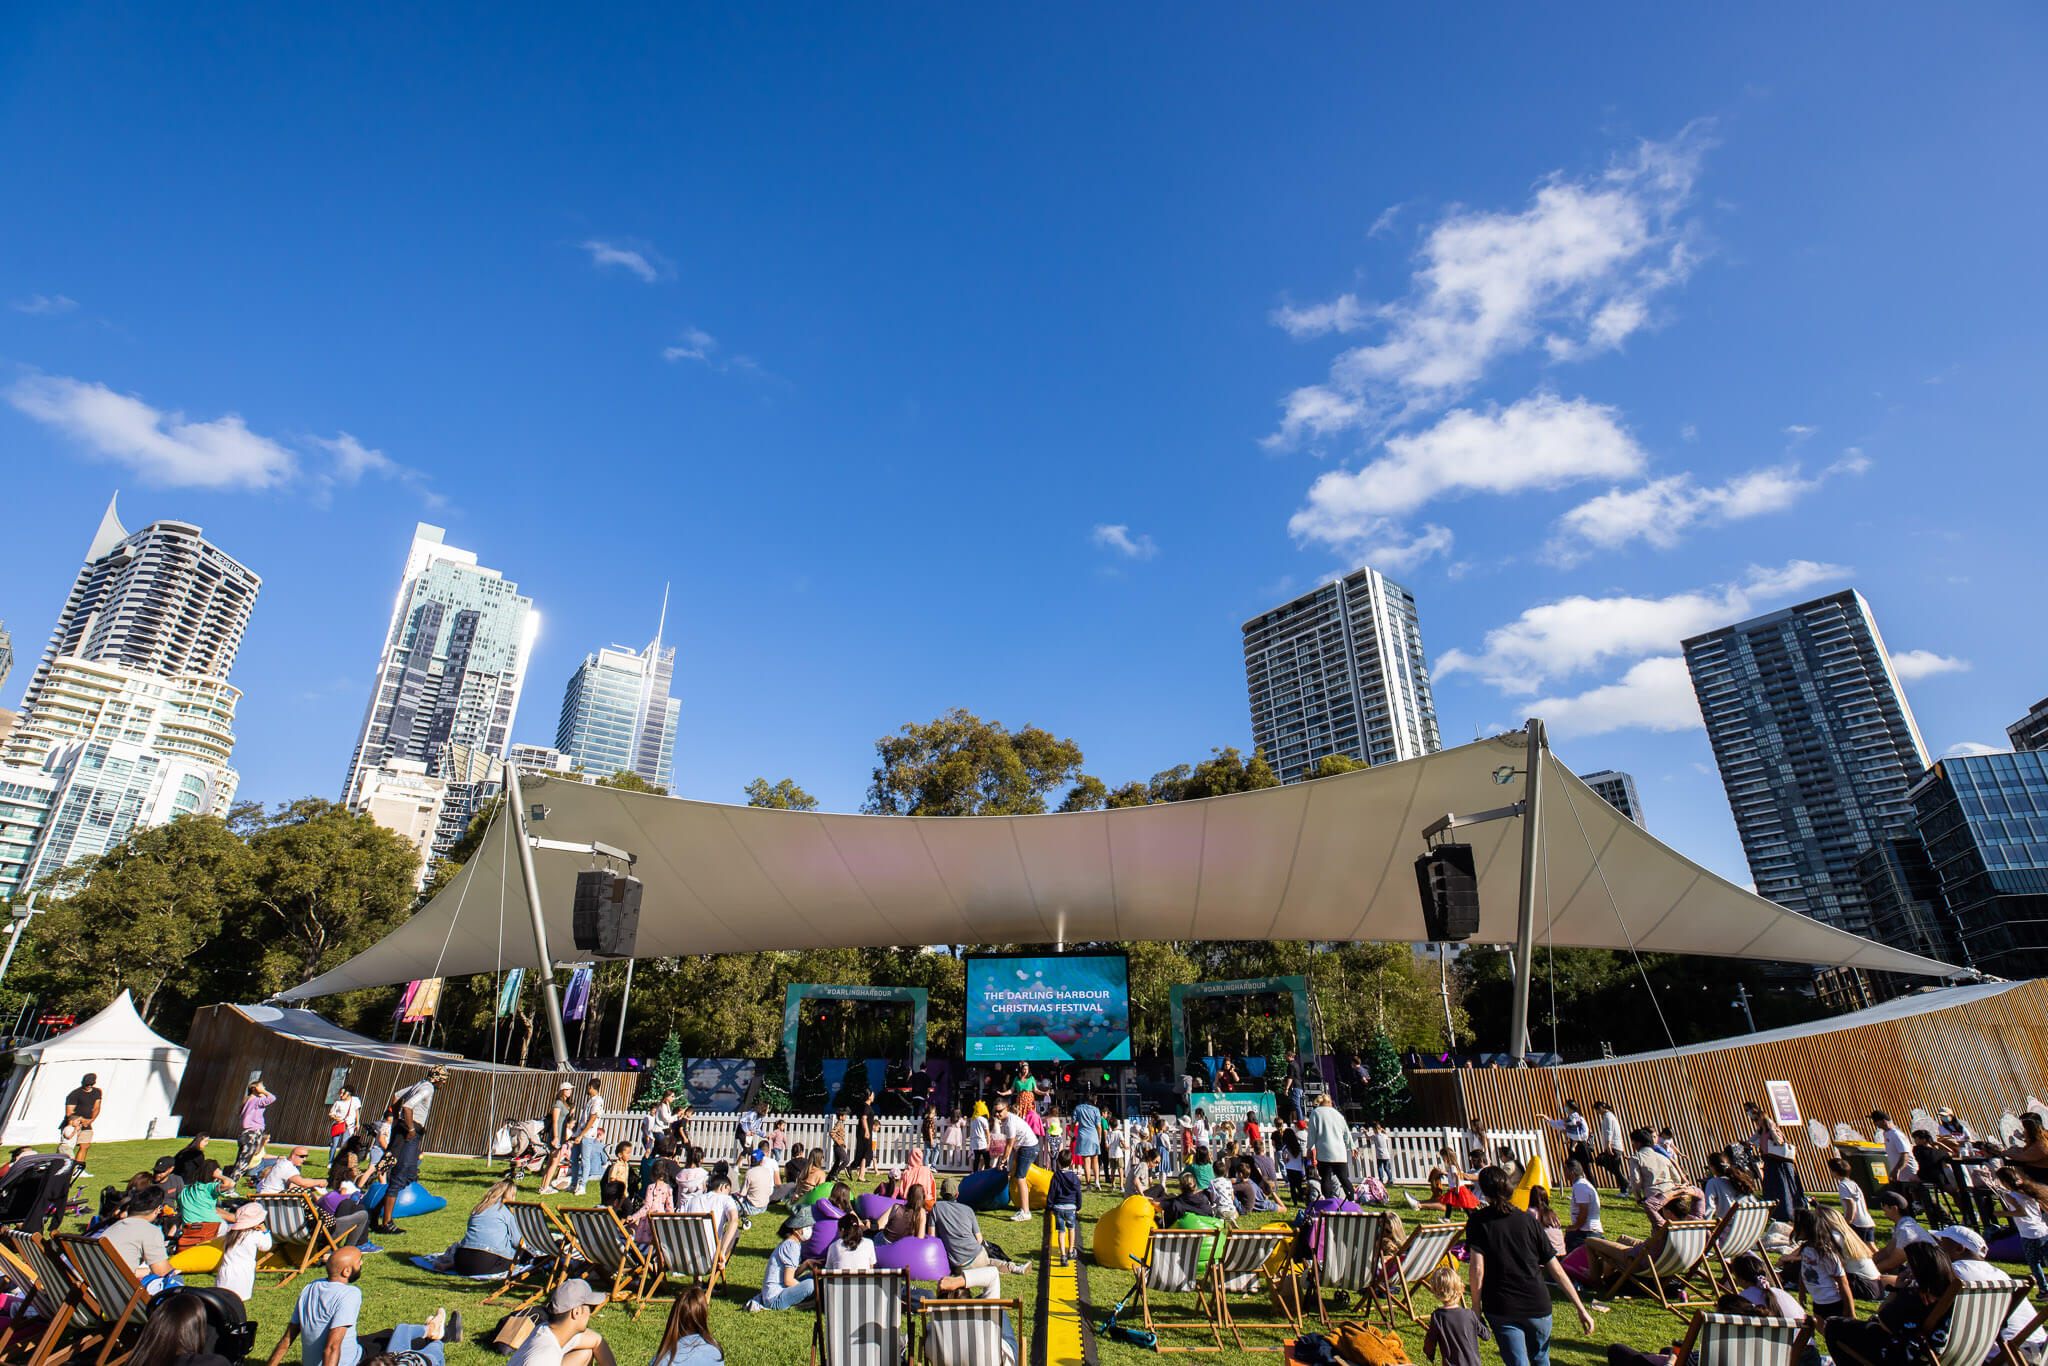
[967,952,1130,1063]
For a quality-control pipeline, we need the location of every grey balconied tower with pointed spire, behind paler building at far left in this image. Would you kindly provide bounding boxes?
[20,500,262,723]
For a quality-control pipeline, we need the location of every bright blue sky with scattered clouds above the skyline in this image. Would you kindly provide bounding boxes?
[0,4,2048,881]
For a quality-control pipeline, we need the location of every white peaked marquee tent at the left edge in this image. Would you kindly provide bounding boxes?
[0,991,184,1147]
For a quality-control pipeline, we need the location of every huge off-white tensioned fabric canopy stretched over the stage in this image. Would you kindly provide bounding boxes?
[285,733,1956,999]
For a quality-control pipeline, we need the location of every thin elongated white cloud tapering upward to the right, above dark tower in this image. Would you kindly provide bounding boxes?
[1542,449,1870,565]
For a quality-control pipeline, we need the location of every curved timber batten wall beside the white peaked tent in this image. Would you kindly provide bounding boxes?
[176,1006,637,1155]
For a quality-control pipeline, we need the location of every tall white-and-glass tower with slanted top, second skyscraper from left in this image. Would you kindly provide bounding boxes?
[342,522,541,852]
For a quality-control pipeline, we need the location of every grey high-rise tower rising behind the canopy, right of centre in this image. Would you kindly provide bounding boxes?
[1243,567,1442,782]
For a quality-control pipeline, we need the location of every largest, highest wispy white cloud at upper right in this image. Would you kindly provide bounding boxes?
[1268,125,1706,444]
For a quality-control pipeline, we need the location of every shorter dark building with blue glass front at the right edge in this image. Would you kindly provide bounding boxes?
[1913,750,2048,977]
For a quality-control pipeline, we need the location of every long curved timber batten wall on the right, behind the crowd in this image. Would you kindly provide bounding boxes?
[1409,979,2048,1190]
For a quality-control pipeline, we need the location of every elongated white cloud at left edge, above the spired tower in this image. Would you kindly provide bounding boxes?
[6,375,297,489]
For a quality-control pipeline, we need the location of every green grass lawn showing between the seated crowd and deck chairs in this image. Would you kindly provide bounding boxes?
[56,1139,2025,1366]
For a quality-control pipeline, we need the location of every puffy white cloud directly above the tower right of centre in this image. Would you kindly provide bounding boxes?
[1288,393,1645,561]
